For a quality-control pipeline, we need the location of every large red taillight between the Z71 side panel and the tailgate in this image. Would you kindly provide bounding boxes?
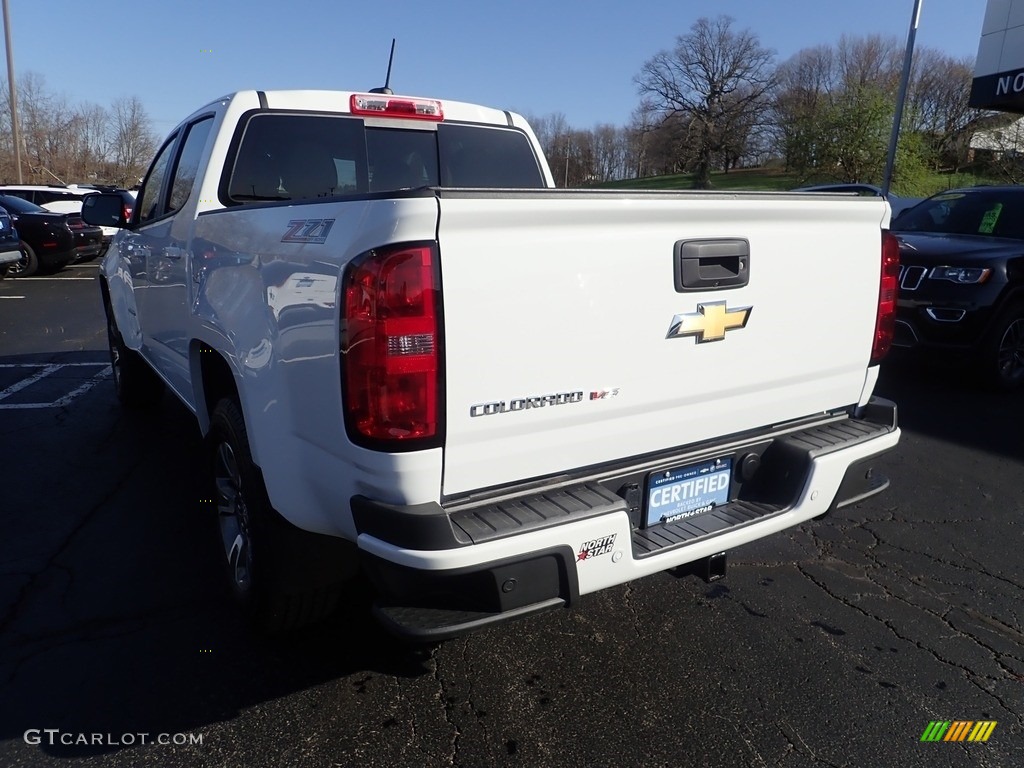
[341,244,440,444]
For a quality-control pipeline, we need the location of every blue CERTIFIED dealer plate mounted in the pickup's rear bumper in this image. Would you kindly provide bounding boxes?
[644,459,732,526]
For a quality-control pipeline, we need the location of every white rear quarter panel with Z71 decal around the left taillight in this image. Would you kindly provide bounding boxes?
[191,196,440,538]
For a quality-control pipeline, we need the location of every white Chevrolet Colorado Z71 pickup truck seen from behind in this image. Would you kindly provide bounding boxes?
[83,91,899,640]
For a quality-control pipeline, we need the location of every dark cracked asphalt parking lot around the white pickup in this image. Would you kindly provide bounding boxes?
[0,265,1024,768]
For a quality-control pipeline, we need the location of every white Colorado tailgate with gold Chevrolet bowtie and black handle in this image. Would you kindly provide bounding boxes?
[438,190,886,497]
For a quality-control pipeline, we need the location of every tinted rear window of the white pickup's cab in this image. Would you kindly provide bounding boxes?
[222,112,545,205]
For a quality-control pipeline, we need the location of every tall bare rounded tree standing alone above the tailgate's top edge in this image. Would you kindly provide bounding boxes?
[635,15,775,188]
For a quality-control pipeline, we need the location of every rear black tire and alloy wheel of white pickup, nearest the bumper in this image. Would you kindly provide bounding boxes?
[210,397,344,633]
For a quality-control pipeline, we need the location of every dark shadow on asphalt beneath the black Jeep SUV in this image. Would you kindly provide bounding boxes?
[876,356,1024,460]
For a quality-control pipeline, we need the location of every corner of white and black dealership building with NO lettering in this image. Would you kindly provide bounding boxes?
[970,0,1024,113]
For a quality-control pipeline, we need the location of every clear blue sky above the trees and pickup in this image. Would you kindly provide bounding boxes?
[0,0,985,137]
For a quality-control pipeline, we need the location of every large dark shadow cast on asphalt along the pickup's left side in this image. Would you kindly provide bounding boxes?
[0,353,428,758]
